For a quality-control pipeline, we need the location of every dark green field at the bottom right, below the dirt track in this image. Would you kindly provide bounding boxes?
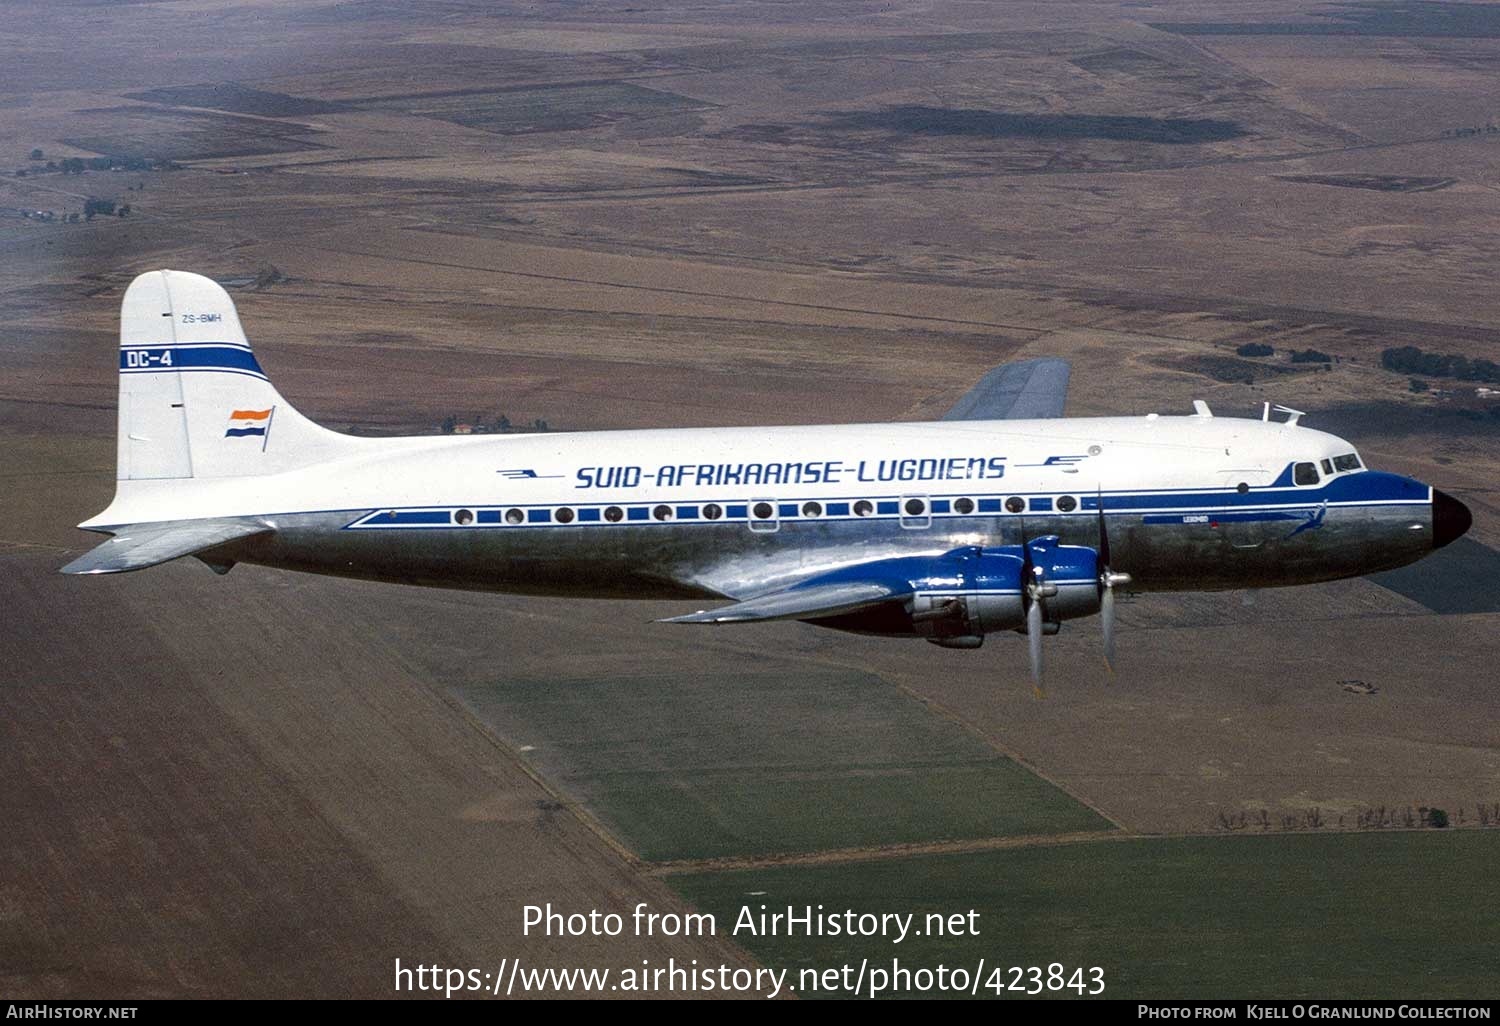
[668,831,1500,999]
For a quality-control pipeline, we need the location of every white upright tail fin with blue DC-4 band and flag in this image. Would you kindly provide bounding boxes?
[116,270,357,482]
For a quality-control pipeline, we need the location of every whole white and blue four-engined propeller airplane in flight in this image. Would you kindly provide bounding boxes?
[63,270,1470,684]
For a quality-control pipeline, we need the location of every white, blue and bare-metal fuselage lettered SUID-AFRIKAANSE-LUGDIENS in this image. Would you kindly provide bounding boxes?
[86,417,1433,597]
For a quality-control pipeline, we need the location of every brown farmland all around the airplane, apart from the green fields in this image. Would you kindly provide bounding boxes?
[0,0,1500,996]
